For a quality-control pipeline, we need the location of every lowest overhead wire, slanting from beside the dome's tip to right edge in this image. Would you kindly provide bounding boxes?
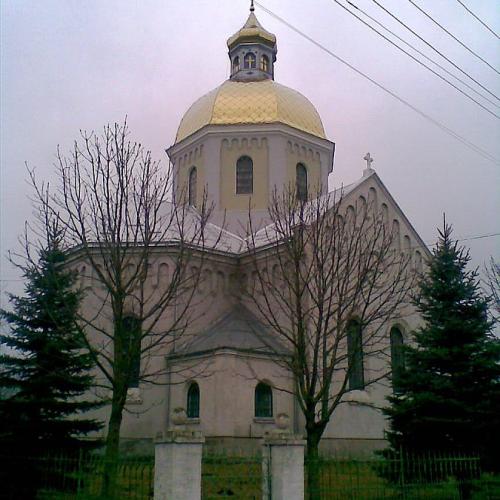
[255,1,500,165]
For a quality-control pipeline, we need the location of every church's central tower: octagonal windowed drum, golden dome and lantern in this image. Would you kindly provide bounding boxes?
[167,5,334,234]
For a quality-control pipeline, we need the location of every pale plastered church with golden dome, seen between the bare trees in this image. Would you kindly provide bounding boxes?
[80,9,427,455]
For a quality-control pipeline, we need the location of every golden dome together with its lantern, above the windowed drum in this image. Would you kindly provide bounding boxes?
[175,5,326,143]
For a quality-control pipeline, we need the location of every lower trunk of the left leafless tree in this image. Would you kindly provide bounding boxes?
[102,388,127,499]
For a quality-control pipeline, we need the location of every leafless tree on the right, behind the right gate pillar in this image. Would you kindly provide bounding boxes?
[247,189,414,498]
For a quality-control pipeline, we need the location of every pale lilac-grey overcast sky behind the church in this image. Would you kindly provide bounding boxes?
[0,0,500,305]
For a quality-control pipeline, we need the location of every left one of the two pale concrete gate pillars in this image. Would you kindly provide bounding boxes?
[154,430,205,500]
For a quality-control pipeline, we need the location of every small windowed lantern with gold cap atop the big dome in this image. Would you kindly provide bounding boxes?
[227,0,277,81]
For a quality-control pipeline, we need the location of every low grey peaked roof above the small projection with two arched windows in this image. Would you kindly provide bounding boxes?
[170,304,288,358]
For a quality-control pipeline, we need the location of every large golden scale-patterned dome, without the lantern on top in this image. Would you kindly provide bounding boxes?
[175,80,325,143]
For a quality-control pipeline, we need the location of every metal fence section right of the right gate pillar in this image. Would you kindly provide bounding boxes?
[306,454,500,500]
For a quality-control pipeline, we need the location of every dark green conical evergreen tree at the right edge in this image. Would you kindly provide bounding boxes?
[385,222,500,466]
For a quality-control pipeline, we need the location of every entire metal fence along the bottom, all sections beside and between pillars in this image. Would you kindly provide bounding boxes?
[0,452,500,500]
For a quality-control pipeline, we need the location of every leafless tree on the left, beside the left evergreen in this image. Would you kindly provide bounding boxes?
[31,122,217,491]
